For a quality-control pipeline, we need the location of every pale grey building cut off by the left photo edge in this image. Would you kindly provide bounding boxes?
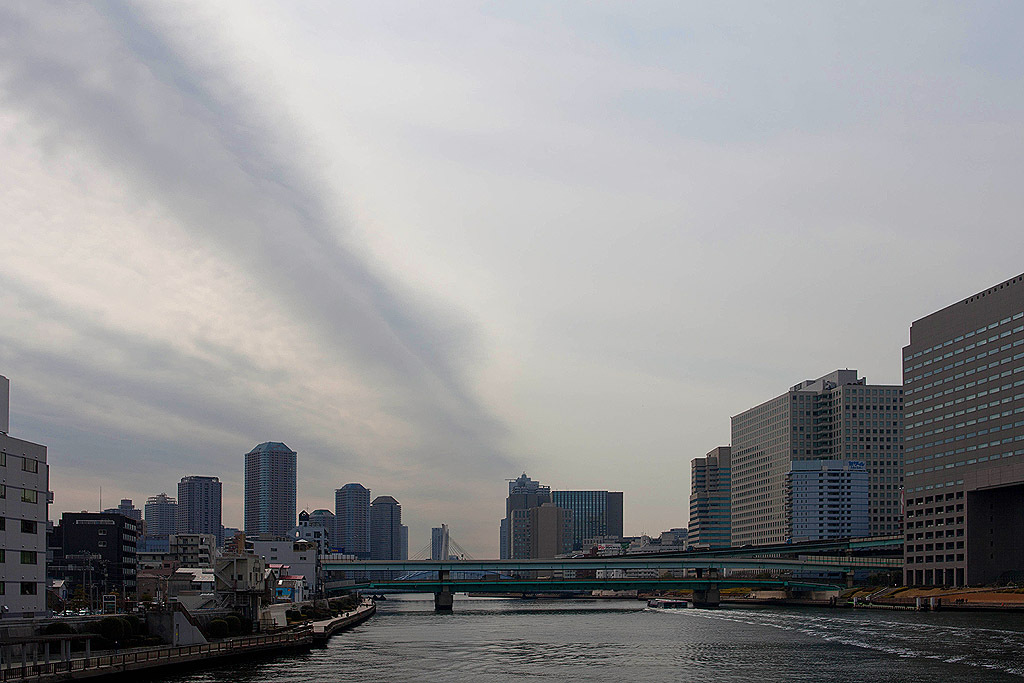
[0,376,50,616]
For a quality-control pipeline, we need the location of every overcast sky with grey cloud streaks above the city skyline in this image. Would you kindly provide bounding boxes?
[0,0,1024,557]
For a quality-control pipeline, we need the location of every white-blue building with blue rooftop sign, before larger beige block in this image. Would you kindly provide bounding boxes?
[785,460,869,543]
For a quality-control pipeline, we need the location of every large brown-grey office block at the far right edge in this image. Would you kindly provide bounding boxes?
[903,274,1024,586]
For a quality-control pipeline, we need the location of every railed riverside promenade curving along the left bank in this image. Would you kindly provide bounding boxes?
[0,602,377,683]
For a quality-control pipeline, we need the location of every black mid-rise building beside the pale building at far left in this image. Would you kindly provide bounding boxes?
[54,512,140,605]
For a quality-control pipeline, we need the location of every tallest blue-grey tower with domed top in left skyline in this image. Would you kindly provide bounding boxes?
[245,441,296,537]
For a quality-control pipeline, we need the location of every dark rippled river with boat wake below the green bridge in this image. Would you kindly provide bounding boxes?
[155,595,1024,683]
